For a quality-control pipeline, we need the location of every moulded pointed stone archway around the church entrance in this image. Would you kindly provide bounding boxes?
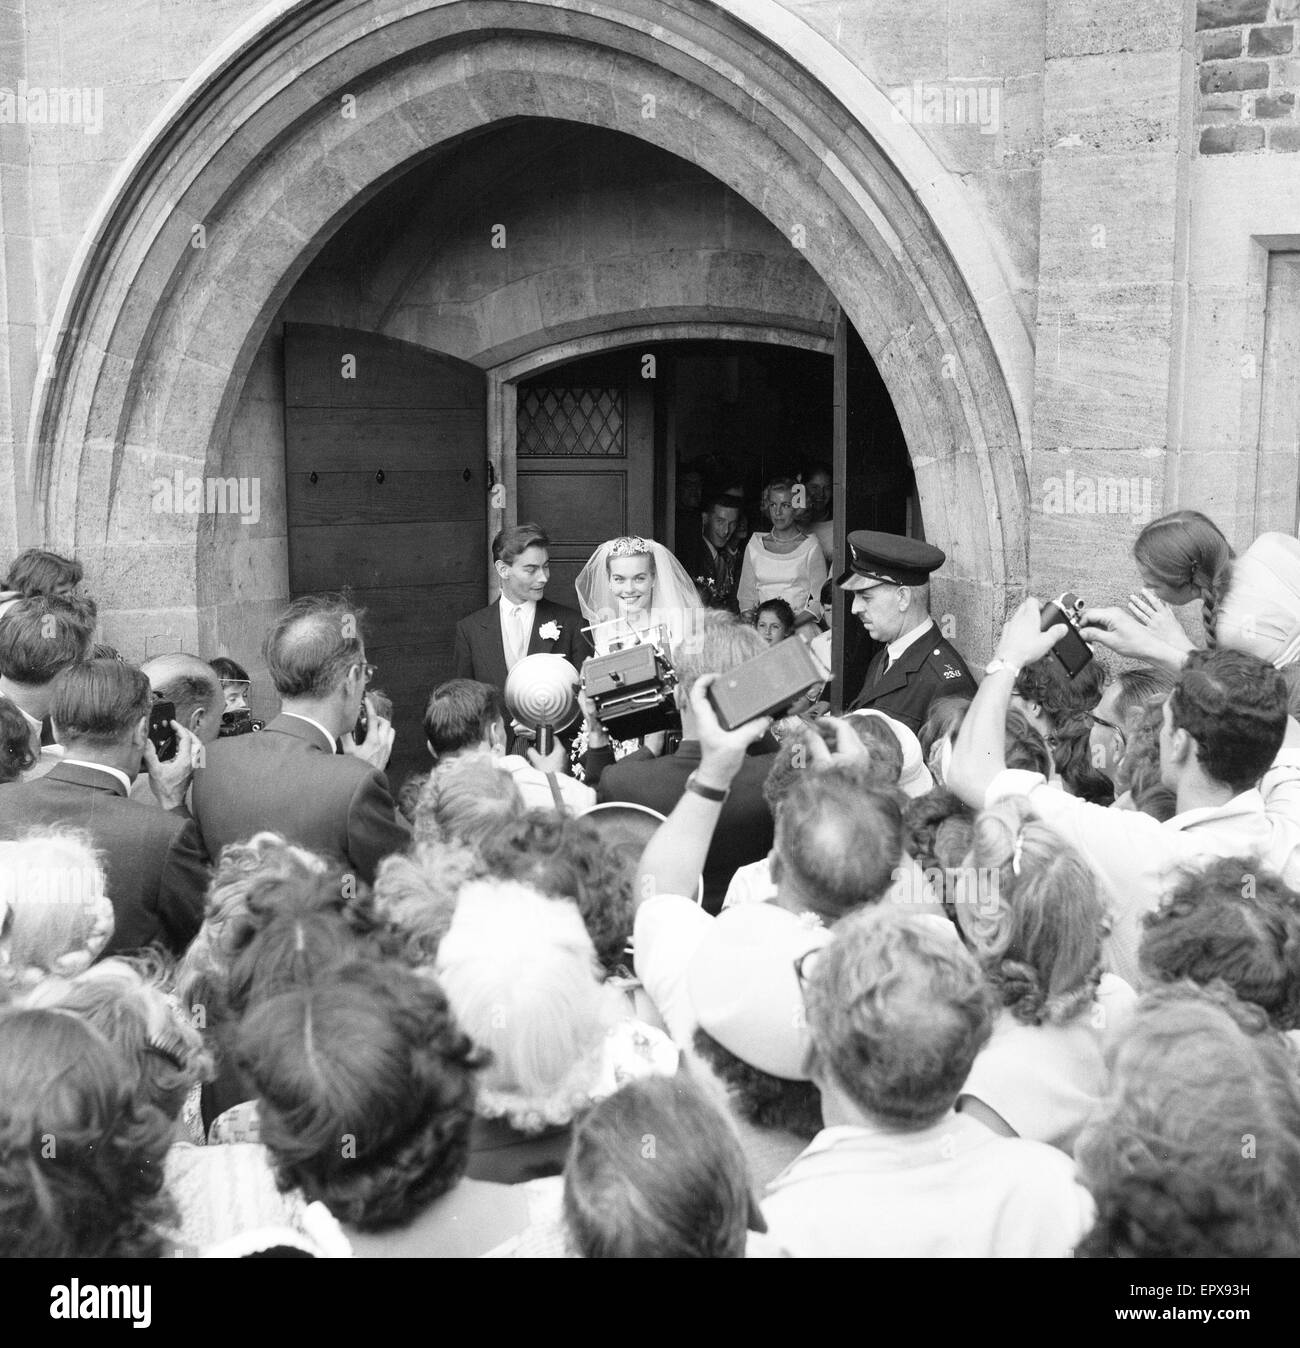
[24,0,1032,650]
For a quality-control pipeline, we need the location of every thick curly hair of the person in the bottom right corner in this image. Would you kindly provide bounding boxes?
[1075,983,1300,1259]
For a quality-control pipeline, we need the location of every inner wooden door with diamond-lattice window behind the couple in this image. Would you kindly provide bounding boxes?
[515,382,654,608]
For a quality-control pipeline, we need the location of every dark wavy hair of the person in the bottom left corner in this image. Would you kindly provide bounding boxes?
[0,1008,175,1259]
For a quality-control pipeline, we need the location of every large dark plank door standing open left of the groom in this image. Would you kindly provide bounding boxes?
[285,324,488,789]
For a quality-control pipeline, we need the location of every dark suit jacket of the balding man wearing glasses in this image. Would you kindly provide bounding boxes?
[194,716,410,884]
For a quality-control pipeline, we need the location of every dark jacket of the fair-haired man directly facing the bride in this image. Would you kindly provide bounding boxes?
[592,740,775,913]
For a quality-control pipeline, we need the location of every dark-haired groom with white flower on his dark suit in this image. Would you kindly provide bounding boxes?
[456,524,592,692]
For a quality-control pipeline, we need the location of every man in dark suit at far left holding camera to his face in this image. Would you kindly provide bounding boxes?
[0,659,209,954]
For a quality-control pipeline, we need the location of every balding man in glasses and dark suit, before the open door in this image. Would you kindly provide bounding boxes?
[194,594,410,884]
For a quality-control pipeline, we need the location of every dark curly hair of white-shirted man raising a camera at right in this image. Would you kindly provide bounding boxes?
[1169,651,1287,793]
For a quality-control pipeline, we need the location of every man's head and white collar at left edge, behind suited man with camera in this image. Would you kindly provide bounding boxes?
[0,594,96,782]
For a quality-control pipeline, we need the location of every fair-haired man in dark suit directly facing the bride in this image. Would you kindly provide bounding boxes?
[585,613,775,913]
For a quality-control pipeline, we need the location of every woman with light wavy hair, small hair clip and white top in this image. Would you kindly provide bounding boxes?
[956,797,1135,1151]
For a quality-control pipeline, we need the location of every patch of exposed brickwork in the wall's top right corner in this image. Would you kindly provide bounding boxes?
[1196,0,1300,155]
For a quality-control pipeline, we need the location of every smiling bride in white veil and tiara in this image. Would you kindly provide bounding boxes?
[574,538,703,655]
